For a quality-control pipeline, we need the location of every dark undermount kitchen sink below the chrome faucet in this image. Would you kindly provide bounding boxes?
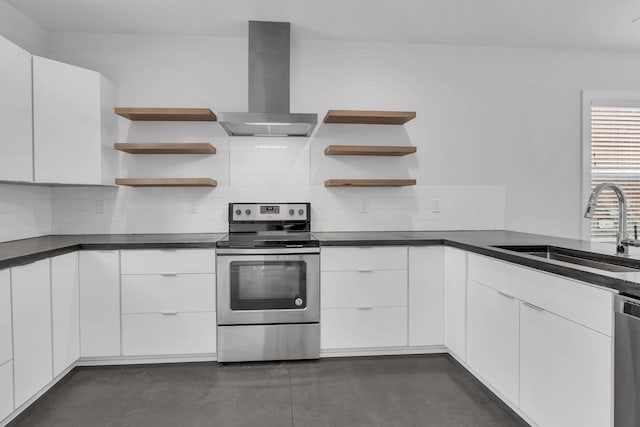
[493,245,640,273]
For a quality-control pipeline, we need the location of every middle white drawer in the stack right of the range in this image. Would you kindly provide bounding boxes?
[320,270,407,308]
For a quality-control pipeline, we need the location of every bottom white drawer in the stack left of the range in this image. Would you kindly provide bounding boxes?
[122,312,216,356]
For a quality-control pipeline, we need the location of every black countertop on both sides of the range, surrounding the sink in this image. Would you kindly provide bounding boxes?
[0,230,640,298]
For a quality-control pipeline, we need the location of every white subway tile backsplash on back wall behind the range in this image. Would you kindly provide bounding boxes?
[51,140,505,234]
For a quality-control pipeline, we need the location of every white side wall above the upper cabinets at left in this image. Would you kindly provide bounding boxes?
[0,0,49,55]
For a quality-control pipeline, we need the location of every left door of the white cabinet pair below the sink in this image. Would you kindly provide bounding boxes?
[467,280,520,405]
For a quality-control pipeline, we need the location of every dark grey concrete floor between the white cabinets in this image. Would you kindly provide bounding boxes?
[10,355,526,427]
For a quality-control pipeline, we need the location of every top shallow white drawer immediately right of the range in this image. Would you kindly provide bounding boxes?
[320,246,407,271]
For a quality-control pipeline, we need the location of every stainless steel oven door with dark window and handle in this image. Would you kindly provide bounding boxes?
[216,248,320,325]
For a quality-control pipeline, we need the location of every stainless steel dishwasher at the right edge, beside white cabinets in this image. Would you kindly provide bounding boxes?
[614,296,640,427]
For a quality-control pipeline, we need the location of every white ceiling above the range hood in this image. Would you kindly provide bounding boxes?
[10,0,640,50]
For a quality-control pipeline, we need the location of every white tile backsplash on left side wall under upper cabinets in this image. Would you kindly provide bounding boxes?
[0,184,52,242]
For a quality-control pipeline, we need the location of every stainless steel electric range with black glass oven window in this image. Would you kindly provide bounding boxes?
[216,203,320,362]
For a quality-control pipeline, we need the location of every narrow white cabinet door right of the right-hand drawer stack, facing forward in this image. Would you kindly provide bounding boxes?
[409,246,444,346]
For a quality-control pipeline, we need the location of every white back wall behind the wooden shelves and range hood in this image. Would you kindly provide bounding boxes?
[45,33,640,237]
